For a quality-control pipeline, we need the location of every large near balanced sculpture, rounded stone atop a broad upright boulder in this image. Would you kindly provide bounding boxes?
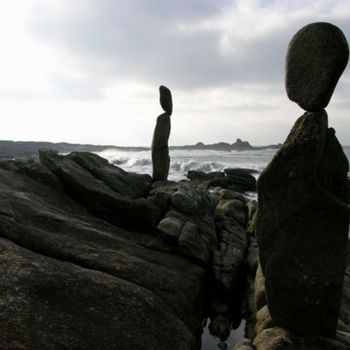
[256,23,349,338]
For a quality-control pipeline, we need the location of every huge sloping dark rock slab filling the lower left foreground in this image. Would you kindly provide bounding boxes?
[0,153,205,350]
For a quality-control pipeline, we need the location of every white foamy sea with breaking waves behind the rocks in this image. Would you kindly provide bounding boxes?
[98,149,276,180]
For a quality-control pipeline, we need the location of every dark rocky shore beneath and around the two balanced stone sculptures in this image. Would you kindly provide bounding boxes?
[0,151,350,350]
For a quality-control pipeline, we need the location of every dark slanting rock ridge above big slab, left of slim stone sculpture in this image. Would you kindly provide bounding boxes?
[39,151,160,231]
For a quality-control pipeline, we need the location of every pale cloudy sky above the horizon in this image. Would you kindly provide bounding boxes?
[0,0,350,146]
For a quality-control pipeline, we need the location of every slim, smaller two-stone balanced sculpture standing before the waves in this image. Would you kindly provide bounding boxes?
[152,86,173,181]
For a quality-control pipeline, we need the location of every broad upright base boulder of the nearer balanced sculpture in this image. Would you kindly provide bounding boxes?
[256,111,349,337]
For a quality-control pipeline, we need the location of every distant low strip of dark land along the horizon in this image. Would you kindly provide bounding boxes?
[0,139,281,160]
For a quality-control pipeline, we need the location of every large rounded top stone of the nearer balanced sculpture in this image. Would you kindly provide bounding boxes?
[285,22,349,112]
